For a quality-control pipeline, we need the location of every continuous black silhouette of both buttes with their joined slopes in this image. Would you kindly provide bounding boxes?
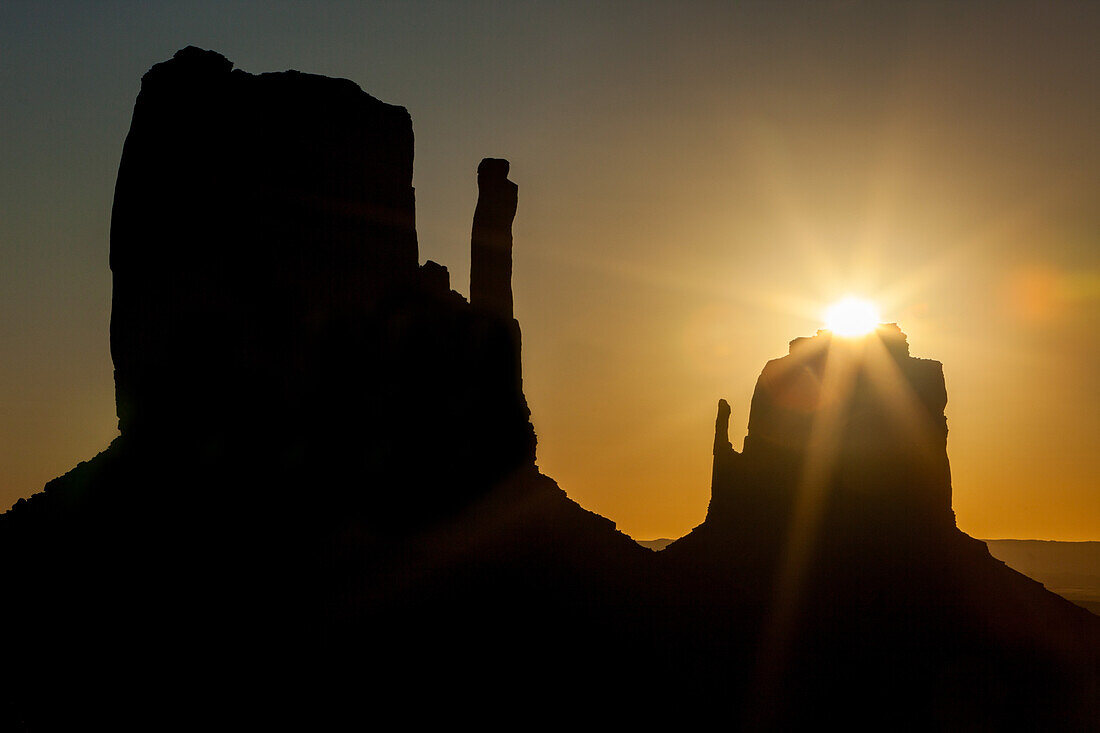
[0,48,1100,731]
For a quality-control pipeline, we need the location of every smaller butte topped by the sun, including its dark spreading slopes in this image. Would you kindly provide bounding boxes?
[659,324,1100,730]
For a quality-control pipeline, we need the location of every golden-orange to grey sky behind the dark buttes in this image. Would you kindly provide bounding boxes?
[0,0,1100,540]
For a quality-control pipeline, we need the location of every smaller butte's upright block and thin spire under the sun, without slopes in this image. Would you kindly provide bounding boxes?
[708,324,955,541]
